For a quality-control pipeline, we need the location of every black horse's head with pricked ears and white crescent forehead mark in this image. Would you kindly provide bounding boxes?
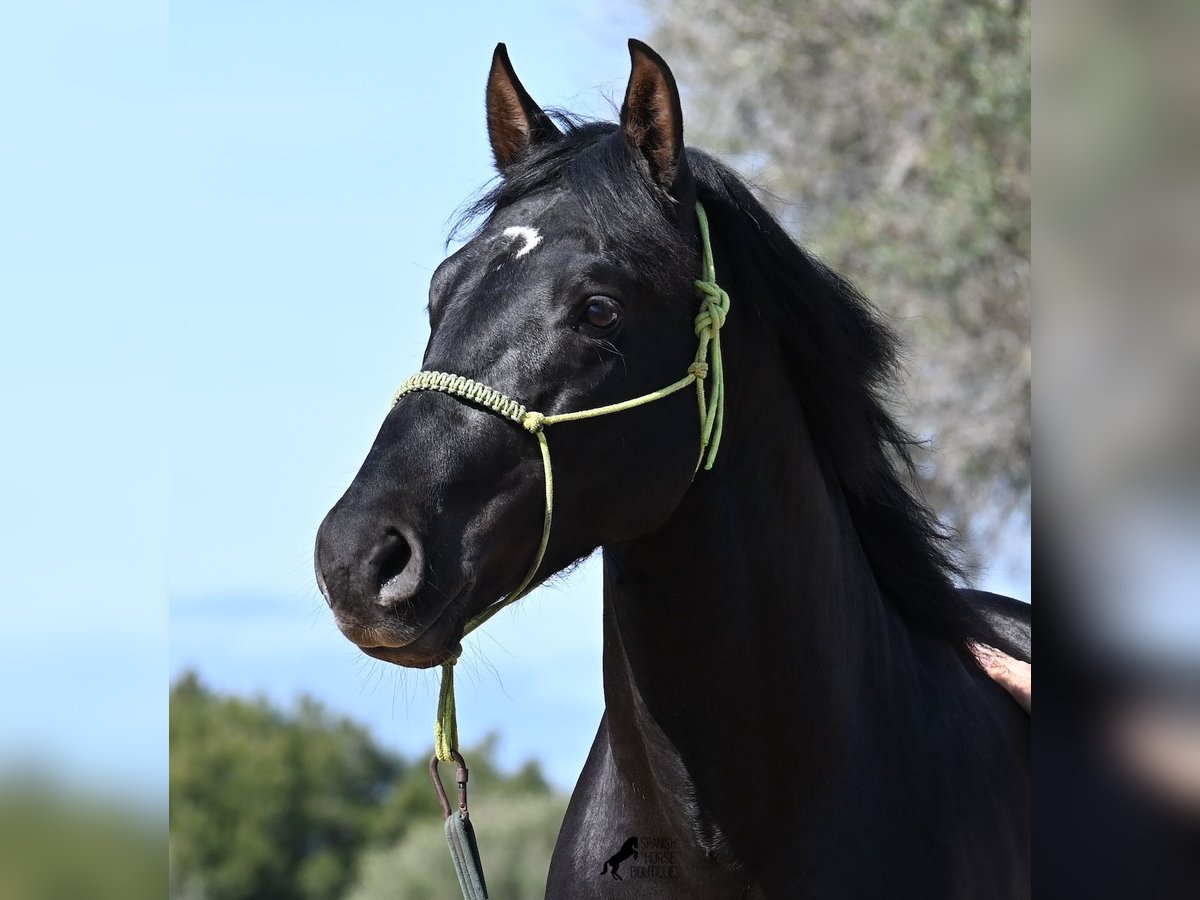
[316,41,703,667]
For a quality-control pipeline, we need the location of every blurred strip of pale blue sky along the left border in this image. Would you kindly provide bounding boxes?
[0,0,168,797]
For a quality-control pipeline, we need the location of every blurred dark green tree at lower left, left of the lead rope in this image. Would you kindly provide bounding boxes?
[169,674,403,900]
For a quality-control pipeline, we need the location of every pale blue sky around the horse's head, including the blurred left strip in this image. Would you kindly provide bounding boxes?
[0,0,1027,796]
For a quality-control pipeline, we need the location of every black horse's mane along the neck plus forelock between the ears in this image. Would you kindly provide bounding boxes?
[451,121,991,647]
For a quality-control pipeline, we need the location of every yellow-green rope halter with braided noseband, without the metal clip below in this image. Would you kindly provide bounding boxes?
[392,203,730,762]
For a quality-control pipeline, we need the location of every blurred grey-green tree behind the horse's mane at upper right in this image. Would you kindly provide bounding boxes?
[644,0,1031,556]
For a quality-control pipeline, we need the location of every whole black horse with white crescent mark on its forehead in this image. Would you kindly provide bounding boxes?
[317,41,1030,900]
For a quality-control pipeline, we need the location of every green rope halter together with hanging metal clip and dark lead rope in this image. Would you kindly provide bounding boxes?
[392,203,730,900]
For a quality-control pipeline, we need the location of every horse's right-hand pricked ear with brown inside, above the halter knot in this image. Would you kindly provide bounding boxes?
[620,38,683,192]
